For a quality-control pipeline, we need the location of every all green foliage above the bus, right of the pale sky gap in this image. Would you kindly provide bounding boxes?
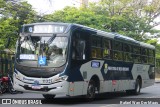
[43,0,160,57]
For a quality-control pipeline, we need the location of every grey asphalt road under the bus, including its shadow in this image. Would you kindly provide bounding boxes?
[0,83,160,107]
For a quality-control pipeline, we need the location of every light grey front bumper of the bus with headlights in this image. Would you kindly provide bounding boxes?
[13,75,69,95]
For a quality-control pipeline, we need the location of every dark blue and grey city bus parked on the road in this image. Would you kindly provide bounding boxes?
[13,22,155,99]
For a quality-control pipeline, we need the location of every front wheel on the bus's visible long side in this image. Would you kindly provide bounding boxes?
[86,80,96,101]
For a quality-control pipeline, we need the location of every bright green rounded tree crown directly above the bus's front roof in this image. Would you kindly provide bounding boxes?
[43,7,107,29]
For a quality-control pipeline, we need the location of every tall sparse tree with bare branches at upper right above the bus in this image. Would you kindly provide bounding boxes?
[90,0,160,41]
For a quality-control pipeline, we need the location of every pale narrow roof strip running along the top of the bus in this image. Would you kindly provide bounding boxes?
[23,22,155,49]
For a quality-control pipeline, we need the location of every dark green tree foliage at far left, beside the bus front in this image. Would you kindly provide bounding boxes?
[0,0,38,50]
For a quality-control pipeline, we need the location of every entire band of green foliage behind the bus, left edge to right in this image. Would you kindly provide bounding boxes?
[0,0,160,56]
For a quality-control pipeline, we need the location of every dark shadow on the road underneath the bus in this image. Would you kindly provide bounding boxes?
[42,92,142,105]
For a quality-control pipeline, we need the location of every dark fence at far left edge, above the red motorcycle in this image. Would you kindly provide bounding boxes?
[0,51,14,77]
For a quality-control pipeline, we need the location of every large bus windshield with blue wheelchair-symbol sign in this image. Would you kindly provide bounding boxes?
[16,35,68,67]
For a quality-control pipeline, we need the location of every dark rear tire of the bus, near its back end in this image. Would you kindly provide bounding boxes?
[126,78,141,95]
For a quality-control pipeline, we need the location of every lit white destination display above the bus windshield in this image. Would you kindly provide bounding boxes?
[24,25,66,33]
